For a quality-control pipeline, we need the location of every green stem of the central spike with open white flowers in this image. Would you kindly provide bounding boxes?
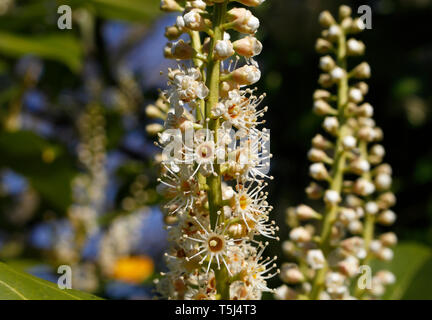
[205,2,229,300]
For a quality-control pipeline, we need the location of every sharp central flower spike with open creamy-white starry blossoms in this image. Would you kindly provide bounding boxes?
[154,0,277,299]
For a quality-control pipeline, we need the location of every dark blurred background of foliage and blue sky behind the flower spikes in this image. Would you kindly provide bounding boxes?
[0,0,432,299]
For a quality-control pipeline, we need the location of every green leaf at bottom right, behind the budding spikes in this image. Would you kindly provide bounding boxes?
[373,242,432,300]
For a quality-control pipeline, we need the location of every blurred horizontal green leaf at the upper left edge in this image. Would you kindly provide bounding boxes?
[0,31,83,72]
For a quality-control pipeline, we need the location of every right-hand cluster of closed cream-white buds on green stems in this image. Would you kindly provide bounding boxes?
[276,6,397,299]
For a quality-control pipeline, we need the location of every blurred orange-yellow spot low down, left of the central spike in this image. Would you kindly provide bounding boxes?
[113,256,154,284]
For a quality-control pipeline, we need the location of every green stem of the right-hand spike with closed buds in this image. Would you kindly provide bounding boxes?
[309,28,349,300]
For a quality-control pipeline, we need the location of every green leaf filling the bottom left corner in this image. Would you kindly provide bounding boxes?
[0,262,101,300]
